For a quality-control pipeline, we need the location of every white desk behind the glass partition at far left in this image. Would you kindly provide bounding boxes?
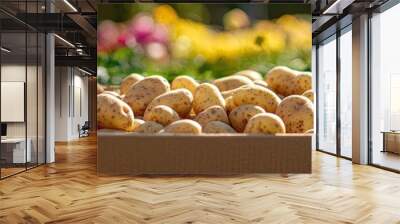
[1,138,32,163]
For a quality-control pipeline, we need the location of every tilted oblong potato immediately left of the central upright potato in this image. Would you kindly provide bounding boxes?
[146,89,193,118]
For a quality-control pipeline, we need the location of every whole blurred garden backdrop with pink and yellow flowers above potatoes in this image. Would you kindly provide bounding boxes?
[97,3,312,85]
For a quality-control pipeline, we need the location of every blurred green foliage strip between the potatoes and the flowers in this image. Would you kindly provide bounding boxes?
[98,46,311,85]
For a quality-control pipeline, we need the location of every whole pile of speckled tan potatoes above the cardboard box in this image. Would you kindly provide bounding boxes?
[97,66,314,134]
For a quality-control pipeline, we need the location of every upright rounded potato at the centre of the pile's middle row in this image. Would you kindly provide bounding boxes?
[193,83,225,114]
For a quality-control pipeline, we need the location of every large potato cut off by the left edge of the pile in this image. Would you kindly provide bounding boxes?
[97,93,134,131]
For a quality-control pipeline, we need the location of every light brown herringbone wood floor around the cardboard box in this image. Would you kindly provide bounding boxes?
[0,135,400,224]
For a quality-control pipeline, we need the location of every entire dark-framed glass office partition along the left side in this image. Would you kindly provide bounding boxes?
[0,1,46,179]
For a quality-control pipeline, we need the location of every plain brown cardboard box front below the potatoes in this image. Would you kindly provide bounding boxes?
[97,131,311,175]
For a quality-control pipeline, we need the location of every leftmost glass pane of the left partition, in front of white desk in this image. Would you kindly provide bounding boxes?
[0,31,27,177]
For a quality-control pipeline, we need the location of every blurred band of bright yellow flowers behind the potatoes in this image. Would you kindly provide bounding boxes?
[164,12,311,62]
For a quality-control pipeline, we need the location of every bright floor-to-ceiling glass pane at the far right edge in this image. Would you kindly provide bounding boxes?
[370,4,400,170]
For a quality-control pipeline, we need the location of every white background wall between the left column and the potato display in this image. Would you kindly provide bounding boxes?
[55,67,88,141]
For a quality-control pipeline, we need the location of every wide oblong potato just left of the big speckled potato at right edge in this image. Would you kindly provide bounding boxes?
[232,85,281,113]
